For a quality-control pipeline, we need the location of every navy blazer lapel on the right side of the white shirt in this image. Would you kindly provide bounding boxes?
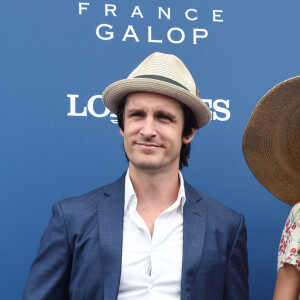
[181,182,206,300]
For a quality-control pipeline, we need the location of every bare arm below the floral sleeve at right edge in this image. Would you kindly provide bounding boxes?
[273,264,300,300]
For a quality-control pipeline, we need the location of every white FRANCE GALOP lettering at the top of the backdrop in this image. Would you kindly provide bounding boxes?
[78,1,224,45]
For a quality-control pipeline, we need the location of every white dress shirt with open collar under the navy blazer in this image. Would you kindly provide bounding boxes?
[118,171,185,300]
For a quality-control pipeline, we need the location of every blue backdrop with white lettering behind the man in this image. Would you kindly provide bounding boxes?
[0,0,300,300]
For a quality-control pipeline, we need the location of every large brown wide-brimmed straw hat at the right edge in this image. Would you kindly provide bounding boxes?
[243,76,300,205]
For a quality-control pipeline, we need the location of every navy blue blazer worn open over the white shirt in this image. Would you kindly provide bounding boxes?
[23,175,249,300]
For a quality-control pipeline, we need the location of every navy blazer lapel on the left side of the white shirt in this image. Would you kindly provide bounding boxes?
[98,176,125,300]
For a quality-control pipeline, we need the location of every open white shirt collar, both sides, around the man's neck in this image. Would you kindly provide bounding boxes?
[124,169,186,213]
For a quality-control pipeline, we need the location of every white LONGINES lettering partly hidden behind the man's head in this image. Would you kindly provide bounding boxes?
[67,94,230,124]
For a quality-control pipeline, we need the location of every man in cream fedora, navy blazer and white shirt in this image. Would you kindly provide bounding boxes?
[23,53,248,300]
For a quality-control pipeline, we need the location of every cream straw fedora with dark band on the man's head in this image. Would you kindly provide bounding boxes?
[102,52,211,128]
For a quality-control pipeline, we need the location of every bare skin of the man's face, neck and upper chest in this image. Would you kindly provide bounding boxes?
[120,92,195,236]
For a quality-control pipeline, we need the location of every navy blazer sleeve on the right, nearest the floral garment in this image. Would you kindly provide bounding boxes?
[224,216,249,300]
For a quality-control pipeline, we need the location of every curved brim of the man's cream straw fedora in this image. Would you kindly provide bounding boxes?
[102,78,211,128]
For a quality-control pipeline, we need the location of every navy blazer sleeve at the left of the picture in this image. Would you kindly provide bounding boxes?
[23,202,72,300]
